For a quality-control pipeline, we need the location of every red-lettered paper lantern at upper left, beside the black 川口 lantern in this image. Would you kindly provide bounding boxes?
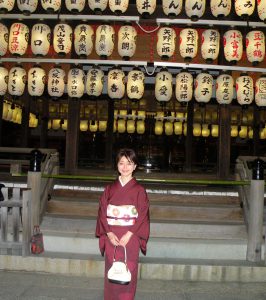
[9,23,29,55]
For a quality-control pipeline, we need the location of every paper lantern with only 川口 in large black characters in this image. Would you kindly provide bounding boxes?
[31,23,51,56]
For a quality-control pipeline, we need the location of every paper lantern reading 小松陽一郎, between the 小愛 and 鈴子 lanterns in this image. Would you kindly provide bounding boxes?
[175,72,193,103]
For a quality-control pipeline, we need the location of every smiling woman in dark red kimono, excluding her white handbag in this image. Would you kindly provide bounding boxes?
[96,149,150,300]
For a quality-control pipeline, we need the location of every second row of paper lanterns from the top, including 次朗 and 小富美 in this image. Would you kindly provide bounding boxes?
[0,23,265,64]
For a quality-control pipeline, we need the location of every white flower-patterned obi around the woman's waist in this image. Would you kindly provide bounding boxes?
[107,204,138,226]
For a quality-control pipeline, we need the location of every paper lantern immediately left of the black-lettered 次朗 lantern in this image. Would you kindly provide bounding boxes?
[95,25,115,59]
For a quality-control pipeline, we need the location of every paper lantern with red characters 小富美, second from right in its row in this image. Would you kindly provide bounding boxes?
[223,29,243,63]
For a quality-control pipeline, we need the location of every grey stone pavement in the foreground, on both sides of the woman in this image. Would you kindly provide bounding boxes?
[0,271,266,300]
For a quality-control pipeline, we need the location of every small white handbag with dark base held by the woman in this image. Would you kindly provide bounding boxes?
[107,246,131,284]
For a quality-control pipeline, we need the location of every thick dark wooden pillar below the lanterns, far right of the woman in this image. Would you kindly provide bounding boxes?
[217,104,231,179]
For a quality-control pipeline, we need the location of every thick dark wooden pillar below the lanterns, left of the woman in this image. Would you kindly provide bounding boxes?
[65,98,80,174]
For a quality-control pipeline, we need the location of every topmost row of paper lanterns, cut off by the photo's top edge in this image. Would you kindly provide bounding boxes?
[0,0,266,21]
